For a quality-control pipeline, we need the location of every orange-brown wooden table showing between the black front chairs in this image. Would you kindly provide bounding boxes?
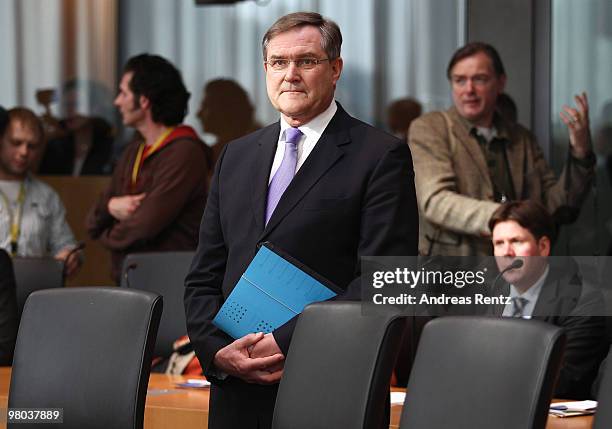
[0,367,593,429]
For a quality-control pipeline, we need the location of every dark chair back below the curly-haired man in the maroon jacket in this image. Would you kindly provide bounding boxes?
[121,252,194,356]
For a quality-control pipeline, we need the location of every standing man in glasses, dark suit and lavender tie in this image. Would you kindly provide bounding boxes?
[185,13,418,428]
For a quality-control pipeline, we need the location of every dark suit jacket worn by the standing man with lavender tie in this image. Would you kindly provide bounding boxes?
[185,105,418,427]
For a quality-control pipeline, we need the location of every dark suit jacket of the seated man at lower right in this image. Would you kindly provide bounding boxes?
[496,258,607,399]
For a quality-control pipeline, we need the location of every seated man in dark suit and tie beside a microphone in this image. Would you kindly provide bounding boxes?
[489,201,606,399]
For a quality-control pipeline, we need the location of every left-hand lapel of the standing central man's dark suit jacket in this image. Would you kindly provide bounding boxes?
[250,122,280,232]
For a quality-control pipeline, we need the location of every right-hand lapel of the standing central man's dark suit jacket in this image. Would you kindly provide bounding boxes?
[259,105,350,241]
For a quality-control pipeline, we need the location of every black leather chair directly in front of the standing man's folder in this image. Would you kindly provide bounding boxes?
[272,301,405,429]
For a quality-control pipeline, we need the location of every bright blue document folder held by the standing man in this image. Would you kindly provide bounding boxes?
[213,243,337,339]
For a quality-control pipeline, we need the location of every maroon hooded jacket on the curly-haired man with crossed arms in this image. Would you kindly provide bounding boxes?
[87,127,211,283]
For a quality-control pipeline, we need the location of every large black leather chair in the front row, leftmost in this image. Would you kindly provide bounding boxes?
[8,287,163,429]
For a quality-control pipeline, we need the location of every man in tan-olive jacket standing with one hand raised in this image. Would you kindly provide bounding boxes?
[409,43,595,256]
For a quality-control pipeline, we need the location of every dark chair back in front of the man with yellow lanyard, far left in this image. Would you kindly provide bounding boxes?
[13,257,64,317]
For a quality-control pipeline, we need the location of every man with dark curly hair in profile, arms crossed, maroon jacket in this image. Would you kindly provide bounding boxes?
[87,54,210,281]
